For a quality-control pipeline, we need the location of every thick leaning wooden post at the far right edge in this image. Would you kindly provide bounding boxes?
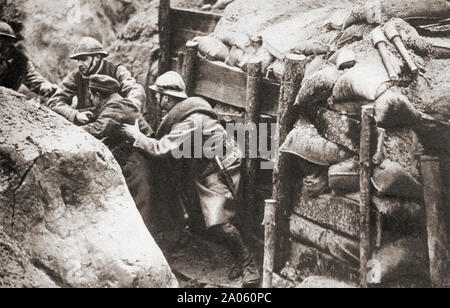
[420,156,450,288]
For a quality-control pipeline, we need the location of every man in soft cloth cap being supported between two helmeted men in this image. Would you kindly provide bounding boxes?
[82,75,156,231]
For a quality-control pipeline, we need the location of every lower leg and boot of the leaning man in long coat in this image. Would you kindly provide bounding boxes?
[214,224,261,287]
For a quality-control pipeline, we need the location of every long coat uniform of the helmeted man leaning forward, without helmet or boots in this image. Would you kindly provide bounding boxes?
[134,97,242,228]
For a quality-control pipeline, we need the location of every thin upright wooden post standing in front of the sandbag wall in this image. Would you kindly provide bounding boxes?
[360,106,375,288]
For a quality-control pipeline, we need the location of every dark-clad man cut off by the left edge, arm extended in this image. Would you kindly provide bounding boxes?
[0,22,57,97]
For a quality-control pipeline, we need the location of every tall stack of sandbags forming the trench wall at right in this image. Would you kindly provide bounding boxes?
[281,16,442,282]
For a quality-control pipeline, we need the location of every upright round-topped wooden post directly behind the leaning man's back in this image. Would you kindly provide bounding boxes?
[244,61,262,234]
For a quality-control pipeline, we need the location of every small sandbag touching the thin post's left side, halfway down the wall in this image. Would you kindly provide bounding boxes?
[328,159,360,194]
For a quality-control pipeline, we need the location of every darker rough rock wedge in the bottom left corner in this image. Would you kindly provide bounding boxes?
[0,228,56,288]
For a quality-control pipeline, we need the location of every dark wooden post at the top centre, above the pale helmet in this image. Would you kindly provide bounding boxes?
[158,0,172,76]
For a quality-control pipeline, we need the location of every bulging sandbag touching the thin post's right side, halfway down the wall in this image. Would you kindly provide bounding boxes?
[372,160,423,201]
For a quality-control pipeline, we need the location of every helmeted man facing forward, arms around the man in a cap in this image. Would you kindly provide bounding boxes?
[48,37,146,125]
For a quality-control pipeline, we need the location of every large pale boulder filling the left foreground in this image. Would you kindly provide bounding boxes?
[0,88,178,287]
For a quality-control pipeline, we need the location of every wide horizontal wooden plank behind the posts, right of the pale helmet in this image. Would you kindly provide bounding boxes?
[194,58,279,117]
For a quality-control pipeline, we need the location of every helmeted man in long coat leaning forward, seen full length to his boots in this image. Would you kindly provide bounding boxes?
[123,72,260,287]
